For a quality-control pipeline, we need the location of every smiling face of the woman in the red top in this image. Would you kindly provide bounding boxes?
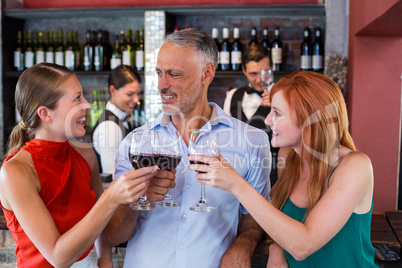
[48,75,91,141]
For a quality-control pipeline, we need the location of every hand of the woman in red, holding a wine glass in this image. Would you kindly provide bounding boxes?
[105,166,158,205]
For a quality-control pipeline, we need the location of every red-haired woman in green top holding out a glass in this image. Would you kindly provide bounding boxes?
[189,71,376,268]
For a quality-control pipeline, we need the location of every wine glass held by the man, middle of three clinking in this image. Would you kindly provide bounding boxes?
[156,130,182,207]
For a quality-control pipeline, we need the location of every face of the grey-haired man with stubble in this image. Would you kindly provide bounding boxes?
[156,42,207,115]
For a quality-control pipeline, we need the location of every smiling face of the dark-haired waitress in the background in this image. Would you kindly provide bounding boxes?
[110,81,141,114]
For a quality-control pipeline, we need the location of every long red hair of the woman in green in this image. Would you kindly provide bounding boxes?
[270,71,356,215]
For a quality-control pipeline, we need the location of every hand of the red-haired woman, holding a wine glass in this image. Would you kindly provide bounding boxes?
[188,155,244,192]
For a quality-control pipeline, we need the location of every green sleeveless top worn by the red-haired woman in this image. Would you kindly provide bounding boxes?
[282,156,377,268]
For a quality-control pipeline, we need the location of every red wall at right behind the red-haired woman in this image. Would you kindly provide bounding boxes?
[348,0,402,212]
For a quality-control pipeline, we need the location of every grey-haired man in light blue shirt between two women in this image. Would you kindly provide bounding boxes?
[105,29,271,268]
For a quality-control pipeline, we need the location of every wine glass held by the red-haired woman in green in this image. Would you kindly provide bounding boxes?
[188,130,220,212]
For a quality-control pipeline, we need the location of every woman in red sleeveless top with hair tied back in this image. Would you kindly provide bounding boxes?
[0,63,171,268]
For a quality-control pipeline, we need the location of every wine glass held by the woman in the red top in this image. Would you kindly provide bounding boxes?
[129,130,158,211]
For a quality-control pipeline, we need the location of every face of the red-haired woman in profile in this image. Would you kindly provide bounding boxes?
[265,90,302,152]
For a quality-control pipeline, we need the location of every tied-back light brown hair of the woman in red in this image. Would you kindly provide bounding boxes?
[6,63,74,156]
